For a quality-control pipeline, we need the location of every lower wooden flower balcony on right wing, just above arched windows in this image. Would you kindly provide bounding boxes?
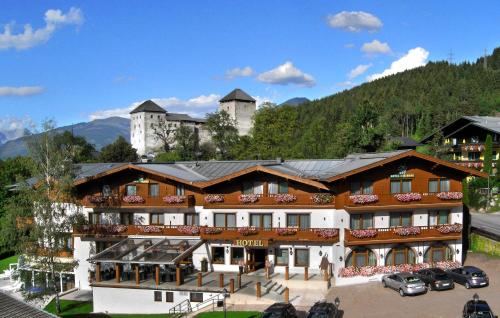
[345,224,462,246]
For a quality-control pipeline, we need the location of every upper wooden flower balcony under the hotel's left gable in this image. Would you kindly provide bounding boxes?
[82,195,195,208]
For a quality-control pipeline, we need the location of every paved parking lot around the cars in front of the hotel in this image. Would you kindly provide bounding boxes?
[327,253,500,318]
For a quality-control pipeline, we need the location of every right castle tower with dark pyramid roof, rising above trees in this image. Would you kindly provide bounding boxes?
[219,88,257,136]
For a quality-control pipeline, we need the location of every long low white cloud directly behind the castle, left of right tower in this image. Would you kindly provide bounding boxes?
[89,94,221,120]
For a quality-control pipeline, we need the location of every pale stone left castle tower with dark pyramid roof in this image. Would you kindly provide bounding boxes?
[130,100,167,156]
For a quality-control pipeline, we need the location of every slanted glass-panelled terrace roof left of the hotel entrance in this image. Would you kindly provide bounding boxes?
[88,238,204,265]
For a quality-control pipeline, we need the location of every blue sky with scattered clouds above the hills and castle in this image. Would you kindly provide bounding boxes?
[0,0,500,138]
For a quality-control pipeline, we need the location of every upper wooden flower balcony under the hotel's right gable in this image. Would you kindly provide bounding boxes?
[345,192,462,212]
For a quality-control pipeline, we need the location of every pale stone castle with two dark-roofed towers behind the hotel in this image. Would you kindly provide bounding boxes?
[130,88,256,156]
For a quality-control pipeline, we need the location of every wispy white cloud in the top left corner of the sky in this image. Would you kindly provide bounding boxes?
[0,7,84,50]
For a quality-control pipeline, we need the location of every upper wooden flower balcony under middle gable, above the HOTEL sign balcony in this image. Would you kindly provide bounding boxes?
[203,193,335,209]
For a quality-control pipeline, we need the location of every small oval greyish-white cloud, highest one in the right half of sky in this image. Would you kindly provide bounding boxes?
[328,11,382,32]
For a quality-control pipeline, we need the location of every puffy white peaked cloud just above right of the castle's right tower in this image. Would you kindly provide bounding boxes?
[257,61,316,87]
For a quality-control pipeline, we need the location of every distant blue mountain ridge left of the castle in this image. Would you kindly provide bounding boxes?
[0,117,130,159]
